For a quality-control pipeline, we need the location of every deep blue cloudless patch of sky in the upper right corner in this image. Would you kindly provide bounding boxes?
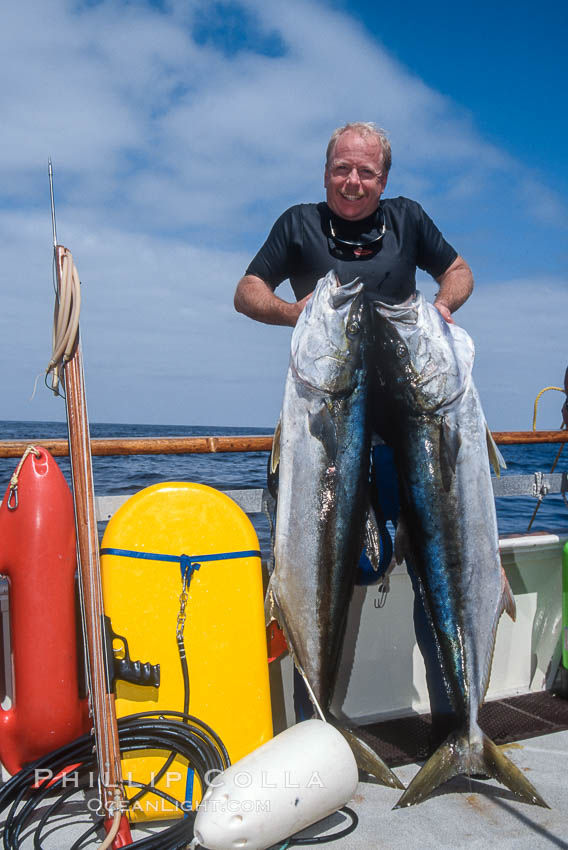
[344,0,568,192]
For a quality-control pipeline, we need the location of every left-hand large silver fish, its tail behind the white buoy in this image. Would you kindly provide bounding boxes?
[267,272,403,787]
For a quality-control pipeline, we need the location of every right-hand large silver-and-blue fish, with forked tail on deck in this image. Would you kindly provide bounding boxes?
[373,293,546,806]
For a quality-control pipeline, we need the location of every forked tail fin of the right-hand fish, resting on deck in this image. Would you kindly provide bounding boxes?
[395,730,548,809]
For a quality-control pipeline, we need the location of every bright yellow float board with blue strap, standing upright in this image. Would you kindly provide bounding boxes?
[101,482,272,820]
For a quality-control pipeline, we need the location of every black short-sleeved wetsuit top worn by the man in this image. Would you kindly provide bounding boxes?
[246,198,457,304]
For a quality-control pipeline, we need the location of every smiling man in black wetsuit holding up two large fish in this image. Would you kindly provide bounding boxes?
[235,123,473,746]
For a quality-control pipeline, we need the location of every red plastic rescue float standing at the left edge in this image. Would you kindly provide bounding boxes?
[0,448,90,773]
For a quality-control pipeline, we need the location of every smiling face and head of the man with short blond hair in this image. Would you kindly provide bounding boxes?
[323,130,387,221]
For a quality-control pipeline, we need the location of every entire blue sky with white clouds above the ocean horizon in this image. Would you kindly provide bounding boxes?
[0,0,568,430]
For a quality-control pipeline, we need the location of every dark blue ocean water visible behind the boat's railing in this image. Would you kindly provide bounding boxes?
[0,422,568,553]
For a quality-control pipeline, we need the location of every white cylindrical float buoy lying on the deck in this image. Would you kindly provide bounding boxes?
[194,720,358,850]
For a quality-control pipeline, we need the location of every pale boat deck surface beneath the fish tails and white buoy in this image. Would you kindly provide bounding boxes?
[4,731,568,850]
